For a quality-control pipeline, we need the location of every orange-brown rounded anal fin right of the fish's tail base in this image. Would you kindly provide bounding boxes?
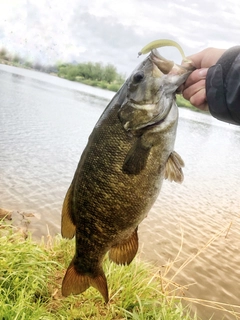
[109,228,138,264]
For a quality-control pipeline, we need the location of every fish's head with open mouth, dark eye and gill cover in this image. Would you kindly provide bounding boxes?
[119,49,194,134]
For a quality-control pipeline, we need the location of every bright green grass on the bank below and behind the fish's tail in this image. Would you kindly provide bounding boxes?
[0,221,195,320]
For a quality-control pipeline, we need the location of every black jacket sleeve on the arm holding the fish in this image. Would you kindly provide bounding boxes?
[206,46,240,125]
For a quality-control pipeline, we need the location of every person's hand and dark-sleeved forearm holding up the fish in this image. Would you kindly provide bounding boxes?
[183,46,240,125]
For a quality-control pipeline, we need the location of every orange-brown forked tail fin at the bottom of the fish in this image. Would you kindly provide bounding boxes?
[62,259,109,303]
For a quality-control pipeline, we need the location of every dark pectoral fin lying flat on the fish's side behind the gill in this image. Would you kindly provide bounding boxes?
[123,139,151,175]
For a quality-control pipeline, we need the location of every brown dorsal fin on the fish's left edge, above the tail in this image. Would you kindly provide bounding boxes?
[61,185,76,239]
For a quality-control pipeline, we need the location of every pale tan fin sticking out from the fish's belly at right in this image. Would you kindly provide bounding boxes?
[165,151,184,183]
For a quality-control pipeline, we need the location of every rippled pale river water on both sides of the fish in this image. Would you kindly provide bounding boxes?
[0,66,240,319]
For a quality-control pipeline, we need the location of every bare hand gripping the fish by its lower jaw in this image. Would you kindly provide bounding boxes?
[181,48,226,111]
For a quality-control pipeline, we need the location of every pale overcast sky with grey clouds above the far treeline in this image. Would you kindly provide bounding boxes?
[0,0,240,75]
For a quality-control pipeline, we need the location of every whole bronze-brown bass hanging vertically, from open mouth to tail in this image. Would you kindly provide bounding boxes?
[61,50,192,302]
